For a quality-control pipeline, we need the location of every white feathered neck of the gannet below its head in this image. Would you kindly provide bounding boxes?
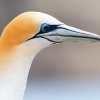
[0,40,50,100]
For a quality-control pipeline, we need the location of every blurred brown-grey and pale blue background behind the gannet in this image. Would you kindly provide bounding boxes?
[0,0,100,100]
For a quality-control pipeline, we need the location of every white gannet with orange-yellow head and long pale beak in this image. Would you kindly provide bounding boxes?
[0,12,100,100]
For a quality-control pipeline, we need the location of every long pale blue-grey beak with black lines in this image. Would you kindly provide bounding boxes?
[36,24,100,43]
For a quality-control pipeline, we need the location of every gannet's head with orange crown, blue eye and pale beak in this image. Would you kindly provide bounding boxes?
[0,12,100,50]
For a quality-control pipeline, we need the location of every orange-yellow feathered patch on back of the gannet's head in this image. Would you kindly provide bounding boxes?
[0,12,42,46]
